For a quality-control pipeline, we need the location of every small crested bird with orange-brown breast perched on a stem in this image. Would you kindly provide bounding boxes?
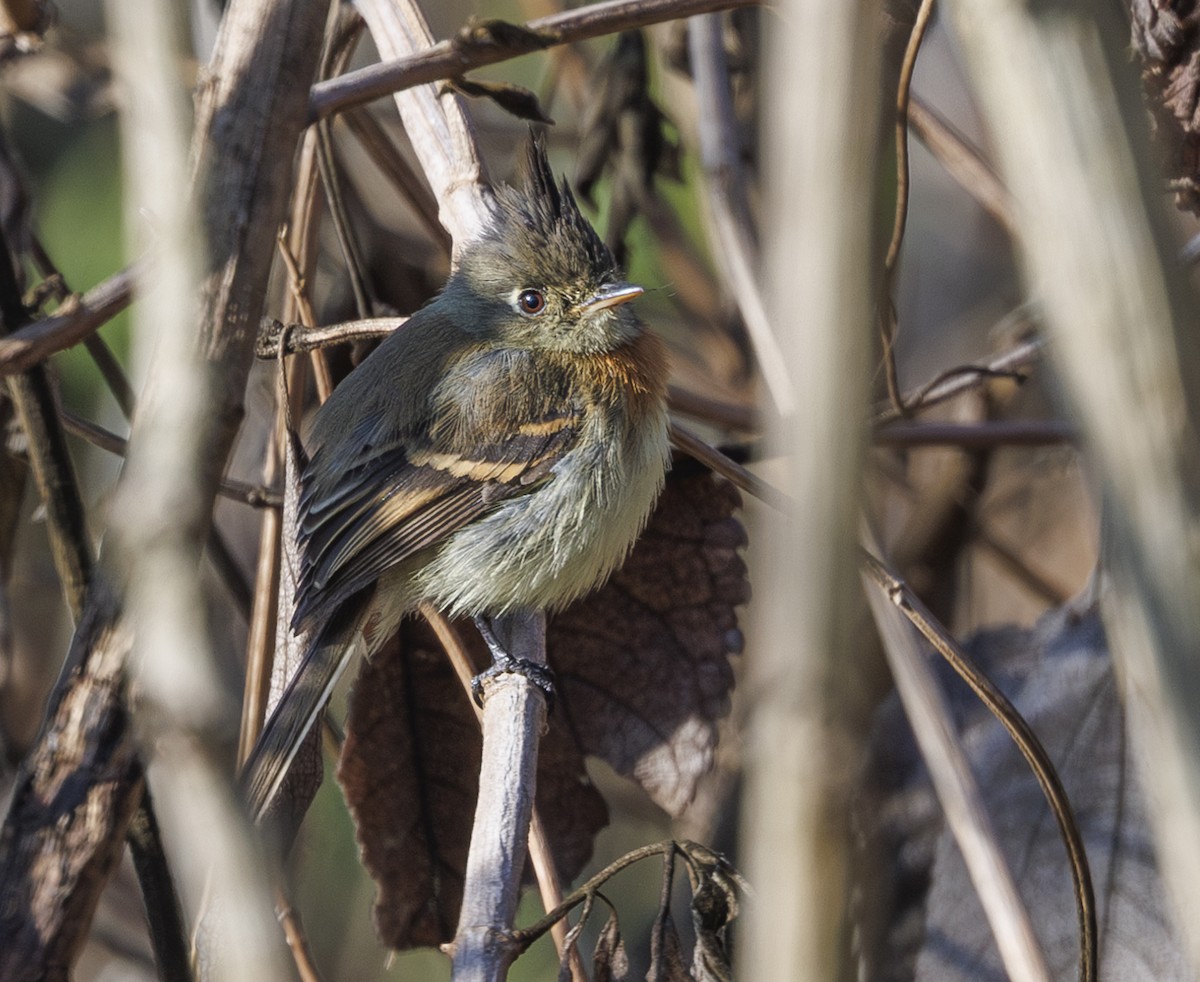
[242,139,670,819]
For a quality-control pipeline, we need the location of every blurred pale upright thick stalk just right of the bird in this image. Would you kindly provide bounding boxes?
[738,0,881,982]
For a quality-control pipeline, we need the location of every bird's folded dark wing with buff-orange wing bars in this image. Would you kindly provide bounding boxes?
[295,350,582,624]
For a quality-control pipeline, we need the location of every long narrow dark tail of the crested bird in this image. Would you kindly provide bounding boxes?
[241,617,362,821]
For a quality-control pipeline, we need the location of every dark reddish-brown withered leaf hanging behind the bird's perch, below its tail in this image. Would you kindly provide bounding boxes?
[337,619,608,950]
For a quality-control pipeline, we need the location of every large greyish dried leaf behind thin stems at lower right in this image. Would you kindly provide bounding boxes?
[858,610,1192,982]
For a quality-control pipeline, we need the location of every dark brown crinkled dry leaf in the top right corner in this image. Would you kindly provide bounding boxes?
[1129,0,1200,214]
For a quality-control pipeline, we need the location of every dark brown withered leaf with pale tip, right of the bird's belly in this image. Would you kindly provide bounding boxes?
[547,461,750,815]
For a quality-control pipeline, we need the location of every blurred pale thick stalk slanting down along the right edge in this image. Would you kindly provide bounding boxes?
[947,0,1200,971]
